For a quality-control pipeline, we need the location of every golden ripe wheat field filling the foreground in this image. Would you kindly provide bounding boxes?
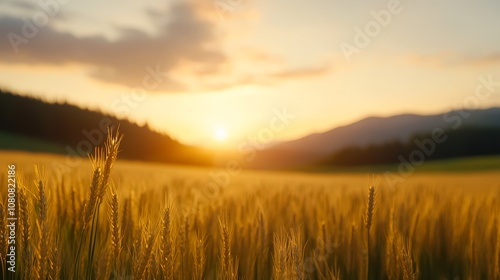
[0,132,500,279]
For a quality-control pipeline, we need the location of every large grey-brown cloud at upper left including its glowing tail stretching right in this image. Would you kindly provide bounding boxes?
[0,1,329,93]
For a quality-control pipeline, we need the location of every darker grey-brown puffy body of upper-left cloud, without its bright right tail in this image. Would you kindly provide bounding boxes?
[0,2,227,92]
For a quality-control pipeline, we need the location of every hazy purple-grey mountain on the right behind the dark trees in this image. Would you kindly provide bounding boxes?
[250,108,500,168]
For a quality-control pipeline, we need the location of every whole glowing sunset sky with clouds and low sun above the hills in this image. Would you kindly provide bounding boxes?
[0,0,500,148]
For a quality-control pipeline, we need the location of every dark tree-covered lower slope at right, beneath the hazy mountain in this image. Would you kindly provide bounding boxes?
[320,127,500,166]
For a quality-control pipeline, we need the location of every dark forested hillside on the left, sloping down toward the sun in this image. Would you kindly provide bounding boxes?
[0,90,211,165]
